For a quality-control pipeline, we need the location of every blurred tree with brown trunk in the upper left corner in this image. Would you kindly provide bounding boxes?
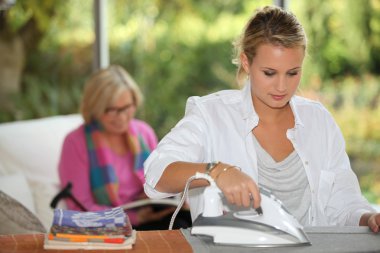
[0,0,64,107]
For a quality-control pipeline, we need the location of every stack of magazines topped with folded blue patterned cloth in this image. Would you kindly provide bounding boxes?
[44,207,136,249]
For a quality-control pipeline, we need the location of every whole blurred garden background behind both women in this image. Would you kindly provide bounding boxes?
[0,0,380,204]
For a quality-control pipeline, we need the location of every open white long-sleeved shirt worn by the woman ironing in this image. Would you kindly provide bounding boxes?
[144,84,374,226]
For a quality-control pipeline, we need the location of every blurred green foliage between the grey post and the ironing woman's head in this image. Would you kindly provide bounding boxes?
[105,1,268,138]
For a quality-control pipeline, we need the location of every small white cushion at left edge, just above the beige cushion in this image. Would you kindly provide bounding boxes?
[0,172,36,214]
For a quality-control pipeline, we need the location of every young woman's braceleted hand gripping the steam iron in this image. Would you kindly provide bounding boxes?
[210,163,261,208]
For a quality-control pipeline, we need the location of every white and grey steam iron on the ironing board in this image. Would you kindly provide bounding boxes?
[191,180,311,247]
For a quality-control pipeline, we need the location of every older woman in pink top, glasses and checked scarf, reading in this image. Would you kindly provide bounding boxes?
[59,66,190,229]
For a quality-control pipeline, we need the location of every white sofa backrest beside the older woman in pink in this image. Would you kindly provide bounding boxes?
[0,114,83,184]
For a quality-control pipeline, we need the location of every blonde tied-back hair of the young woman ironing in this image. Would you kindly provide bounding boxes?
[232,6,307,84]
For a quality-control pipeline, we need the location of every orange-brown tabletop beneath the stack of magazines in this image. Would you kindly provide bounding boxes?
[0,230,193,253]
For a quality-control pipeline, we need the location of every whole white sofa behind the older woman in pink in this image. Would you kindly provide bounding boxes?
[0,114,83,229]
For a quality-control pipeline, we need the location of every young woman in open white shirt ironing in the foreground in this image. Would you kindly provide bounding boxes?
[145,7,380,232]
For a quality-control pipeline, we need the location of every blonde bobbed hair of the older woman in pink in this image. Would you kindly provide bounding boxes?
[80,65,143,123]
